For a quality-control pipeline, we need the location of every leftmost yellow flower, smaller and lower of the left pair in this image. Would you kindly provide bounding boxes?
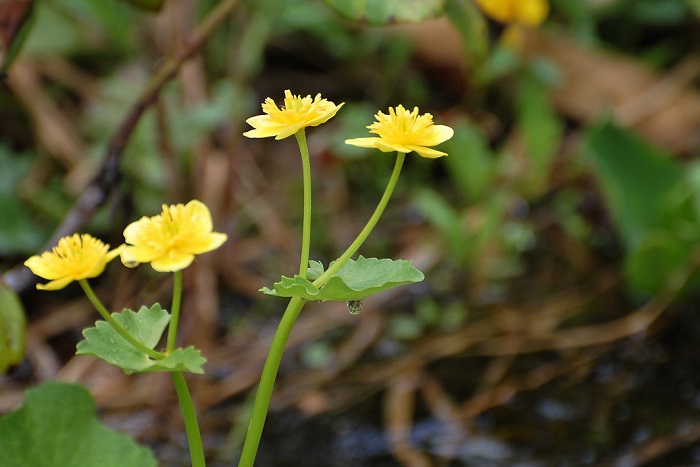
[24,234,121,290]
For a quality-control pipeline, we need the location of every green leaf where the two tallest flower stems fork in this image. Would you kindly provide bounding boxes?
[260,256,425,301]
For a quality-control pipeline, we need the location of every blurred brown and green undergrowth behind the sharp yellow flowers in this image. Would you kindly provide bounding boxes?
[0,0,700,466]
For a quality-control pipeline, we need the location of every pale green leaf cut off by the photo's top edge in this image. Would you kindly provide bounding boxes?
[325,0,445,25]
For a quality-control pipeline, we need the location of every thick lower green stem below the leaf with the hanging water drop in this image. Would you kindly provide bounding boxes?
[238,297,306,467]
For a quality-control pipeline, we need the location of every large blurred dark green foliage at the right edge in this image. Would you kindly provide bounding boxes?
[588,123,700,293]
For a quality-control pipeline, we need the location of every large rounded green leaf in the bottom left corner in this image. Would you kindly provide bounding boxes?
[0,382,156,467]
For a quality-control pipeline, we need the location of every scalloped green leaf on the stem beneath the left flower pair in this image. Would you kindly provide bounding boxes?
[76,304,206,374]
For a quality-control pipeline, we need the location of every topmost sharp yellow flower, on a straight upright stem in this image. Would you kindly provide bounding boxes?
[243,90,344,139]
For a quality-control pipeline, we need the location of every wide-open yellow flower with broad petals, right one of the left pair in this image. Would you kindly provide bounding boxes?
[121,200,226,272]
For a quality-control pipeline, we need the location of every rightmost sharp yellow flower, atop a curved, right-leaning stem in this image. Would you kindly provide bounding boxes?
[345,105,454,158]
